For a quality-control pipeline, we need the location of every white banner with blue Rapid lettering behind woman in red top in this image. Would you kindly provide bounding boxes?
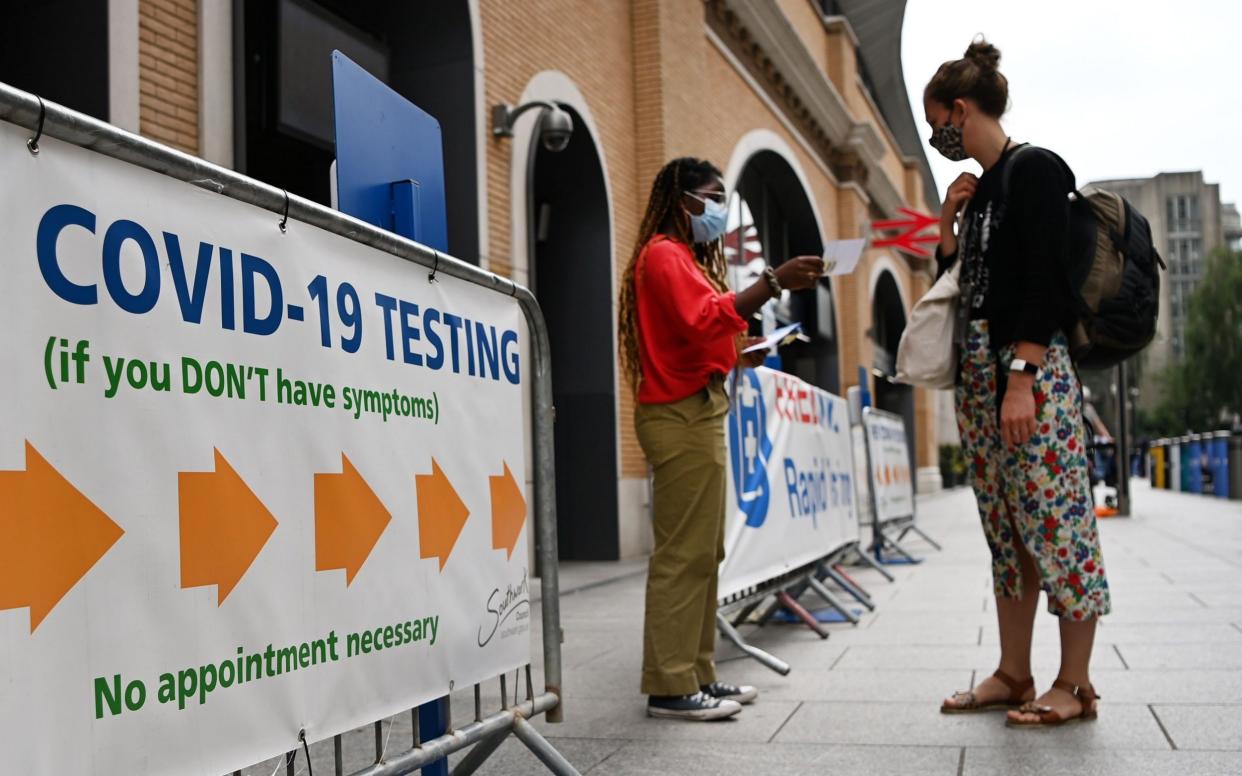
[718,369,858,600]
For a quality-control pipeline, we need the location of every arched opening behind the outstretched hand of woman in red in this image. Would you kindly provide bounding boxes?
[725,150,840,394]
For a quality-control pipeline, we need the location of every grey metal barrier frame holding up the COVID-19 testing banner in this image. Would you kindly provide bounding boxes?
[0,83,578,776]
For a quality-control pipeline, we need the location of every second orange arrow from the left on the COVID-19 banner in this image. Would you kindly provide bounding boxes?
[176,449,276,606]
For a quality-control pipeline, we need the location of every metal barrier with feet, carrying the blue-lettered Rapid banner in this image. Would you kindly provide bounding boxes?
[717,369,874,674]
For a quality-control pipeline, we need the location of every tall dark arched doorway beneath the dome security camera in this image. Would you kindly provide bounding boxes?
[527,104,621,560]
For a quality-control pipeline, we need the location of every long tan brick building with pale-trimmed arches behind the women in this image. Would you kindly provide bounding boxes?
[0,0,943,559]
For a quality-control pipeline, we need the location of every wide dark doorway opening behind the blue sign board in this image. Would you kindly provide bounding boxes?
[233,0,479,263]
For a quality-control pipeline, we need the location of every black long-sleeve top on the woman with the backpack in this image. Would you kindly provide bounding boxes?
[936,147,1074,351]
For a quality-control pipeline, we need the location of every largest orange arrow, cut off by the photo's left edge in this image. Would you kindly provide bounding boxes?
[0,442,125,633]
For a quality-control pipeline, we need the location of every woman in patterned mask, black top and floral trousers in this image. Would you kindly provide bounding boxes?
[923,40,1109,728]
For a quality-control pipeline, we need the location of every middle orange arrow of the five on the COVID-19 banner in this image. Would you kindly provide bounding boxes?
[314,453,392,587]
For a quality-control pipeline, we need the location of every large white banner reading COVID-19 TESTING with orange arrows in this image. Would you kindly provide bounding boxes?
[0,122,530,776]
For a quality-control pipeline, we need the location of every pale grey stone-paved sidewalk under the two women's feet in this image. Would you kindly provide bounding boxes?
[244,480,1242,776]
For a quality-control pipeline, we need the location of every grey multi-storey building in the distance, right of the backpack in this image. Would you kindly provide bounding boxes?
[1090,171,1236,410]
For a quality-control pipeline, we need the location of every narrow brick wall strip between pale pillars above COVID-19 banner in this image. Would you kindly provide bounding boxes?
[138,0,199,154]
